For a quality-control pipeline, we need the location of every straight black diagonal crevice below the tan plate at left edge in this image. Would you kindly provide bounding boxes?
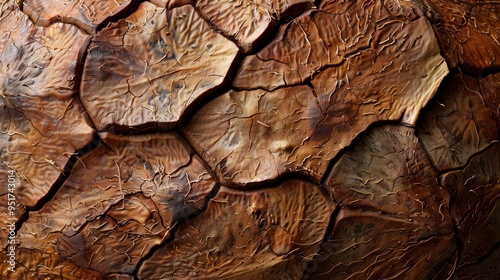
[16,133,101,232]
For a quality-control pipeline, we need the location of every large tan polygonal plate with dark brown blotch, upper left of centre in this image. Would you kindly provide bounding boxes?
[81,2,238,132]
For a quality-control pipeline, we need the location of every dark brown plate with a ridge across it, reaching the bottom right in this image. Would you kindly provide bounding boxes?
[307,126,456,279]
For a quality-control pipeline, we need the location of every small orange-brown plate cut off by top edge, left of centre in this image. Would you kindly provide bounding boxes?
[23,0,133,34]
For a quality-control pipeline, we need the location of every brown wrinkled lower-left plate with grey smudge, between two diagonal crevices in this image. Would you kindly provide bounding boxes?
[17,134,215,273]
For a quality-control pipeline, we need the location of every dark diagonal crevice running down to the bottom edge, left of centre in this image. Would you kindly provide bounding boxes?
[132,184,220,279]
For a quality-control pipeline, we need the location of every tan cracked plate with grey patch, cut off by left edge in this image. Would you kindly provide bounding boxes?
[0,4,93,207]
